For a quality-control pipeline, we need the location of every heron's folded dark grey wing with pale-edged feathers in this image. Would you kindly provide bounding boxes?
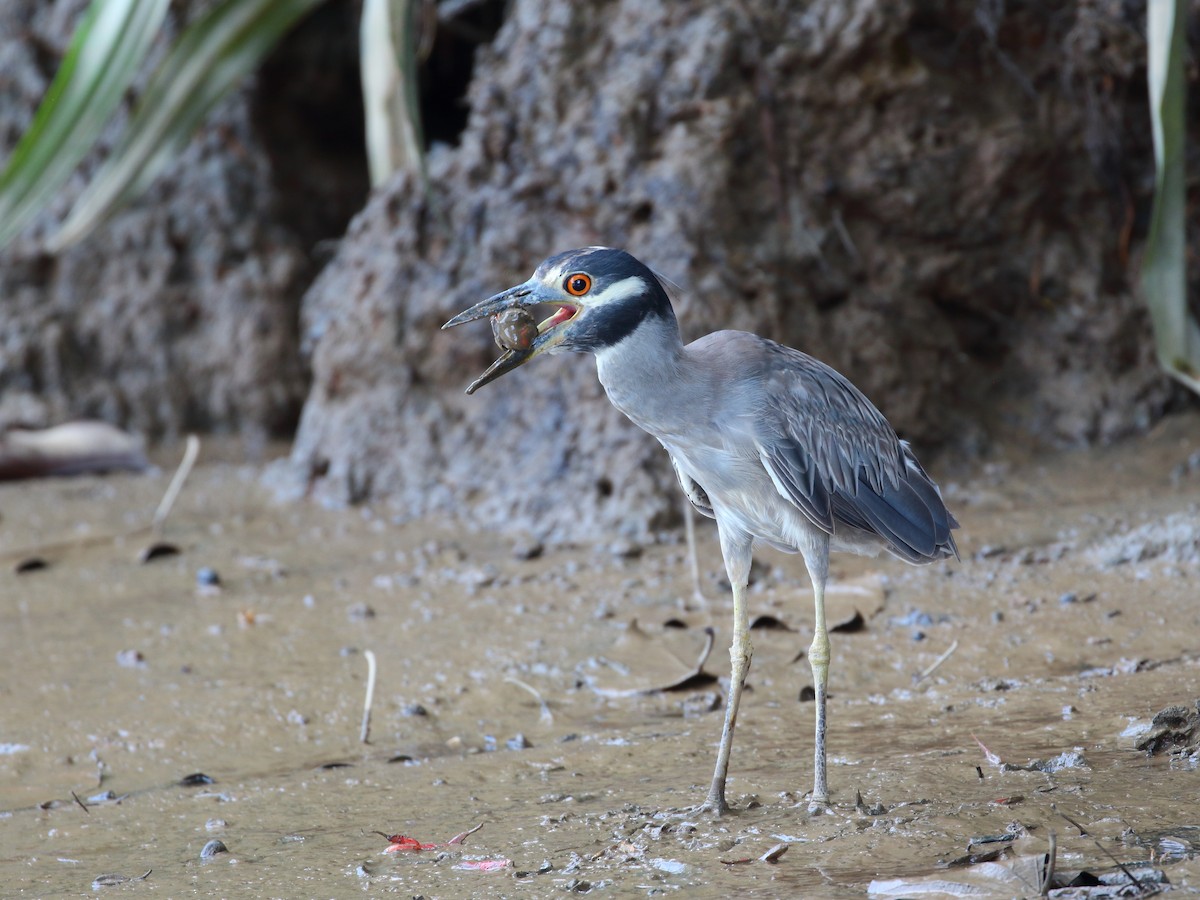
[755,341,958,563]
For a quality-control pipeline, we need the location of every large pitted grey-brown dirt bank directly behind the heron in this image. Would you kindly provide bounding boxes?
[293,0,1178,535]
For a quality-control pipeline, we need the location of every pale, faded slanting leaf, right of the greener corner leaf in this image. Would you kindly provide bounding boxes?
[49,0,320,252]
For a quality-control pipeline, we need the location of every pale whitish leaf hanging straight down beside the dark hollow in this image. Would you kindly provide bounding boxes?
[359,0,425,185]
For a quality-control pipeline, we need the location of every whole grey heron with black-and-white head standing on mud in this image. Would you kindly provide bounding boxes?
[444,247,958,814]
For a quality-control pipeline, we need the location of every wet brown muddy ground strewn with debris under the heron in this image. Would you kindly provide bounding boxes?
[0,415,1200,898]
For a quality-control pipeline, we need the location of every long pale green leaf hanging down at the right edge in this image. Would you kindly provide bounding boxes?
[1141,0,1200,392]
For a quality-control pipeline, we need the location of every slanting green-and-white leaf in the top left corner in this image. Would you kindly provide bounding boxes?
[0,0,169,247]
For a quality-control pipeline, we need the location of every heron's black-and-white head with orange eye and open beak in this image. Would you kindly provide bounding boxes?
[442,247,674,394]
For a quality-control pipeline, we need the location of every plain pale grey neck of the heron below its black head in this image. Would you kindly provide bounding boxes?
[595,316,685,436]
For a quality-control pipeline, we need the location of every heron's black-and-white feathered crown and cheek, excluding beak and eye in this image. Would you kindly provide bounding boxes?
[534,247,674,352]
